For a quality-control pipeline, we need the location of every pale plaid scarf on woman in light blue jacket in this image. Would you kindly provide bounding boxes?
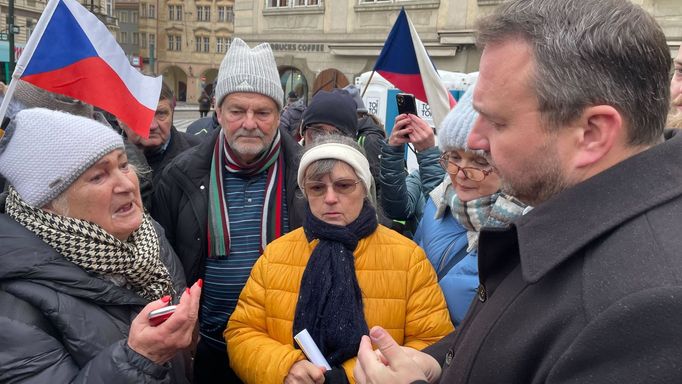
[444,185,526,251]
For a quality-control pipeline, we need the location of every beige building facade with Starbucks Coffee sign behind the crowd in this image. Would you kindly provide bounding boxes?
[234,0,682,106]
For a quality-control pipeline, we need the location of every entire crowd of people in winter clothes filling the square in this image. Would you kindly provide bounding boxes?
[0,0,682,384]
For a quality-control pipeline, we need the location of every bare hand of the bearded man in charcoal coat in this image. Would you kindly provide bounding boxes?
[353,327,441,384]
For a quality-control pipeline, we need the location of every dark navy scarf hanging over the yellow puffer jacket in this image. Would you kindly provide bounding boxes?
[294,201,377,366]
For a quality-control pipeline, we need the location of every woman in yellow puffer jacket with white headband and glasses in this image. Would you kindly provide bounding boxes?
[224,136,453,384]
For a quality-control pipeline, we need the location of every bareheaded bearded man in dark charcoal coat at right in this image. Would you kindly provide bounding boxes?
[355,0,682,383]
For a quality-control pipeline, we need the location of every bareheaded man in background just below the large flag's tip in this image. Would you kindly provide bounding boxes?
[119,83,201,184]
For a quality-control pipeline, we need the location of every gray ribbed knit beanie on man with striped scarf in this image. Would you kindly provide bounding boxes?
[215,38,284,110]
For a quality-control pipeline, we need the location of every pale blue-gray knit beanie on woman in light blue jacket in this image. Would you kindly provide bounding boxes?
[438,83,478,152]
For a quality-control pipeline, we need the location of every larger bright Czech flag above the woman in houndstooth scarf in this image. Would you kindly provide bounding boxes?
[13,0,161,137]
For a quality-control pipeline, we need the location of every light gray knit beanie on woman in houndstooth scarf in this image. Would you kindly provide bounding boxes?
[0,108,123,208]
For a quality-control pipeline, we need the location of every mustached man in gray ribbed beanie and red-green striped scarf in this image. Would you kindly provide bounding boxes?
[152,38,305,383]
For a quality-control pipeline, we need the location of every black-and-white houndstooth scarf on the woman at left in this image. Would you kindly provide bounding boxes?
[5,187,175,301]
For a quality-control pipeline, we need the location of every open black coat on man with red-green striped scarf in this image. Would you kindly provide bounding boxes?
[152,130,306,281]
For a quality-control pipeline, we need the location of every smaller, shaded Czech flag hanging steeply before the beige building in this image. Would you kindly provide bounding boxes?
[374,8,456,127]
